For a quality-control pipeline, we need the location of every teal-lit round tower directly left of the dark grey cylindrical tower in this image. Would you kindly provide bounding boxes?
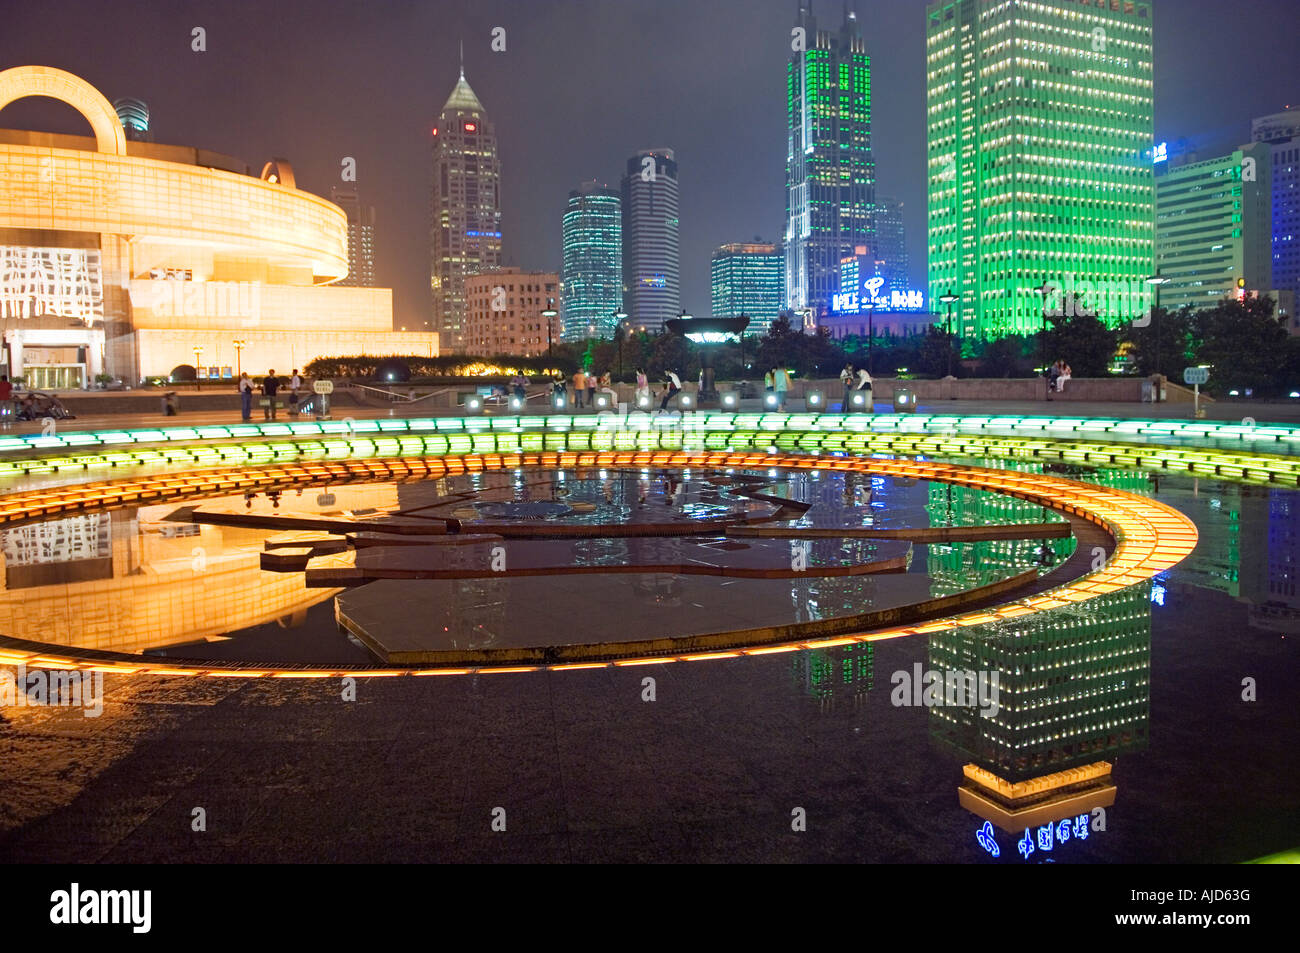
[562,179,623,341]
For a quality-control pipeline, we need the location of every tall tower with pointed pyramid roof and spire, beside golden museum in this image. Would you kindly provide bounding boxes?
[429,66,501,354]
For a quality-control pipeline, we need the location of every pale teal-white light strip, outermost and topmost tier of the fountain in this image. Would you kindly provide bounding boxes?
[0,411,1300,458]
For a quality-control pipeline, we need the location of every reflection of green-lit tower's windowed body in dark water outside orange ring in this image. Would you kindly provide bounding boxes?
[930,582,1151,783]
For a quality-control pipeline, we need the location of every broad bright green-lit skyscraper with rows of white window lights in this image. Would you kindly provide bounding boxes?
[926,0,1154,338]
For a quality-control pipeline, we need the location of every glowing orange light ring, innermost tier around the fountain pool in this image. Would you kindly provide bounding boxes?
[0,450,1197,679]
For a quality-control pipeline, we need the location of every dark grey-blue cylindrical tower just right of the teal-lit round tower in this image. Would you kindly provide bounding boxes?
[621,150,681,333]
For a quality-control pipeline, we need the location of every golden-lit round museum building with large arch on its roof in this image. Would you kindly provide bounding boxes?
[0,66,438,389]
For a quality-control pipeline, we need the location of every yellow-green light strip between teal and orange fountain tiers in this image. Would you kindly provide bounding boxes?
[0,429,1300,486]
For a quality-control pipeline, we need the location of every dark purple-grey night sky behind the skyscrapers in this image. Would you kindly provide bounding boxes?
[0,0,1300,326]
